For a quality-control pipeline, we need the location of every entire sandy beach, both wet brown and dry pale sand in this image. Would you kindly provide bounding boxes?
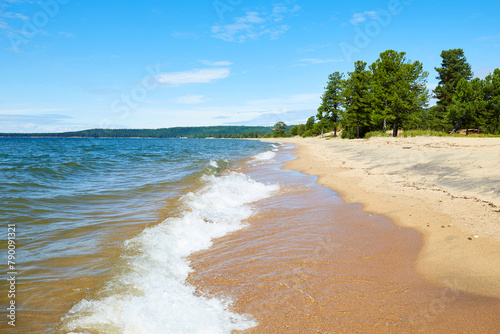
[188,138,500,333]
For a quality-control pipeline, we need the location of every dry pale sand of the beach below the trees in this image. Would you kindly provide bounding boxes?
[260,137,500,298]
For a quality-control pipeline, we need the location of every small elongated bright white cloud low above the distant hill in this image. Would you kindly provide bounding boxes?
[157,67,231,86]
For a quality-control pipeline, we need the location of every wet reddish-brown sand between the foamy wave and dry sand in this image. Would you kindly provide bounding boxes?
[189,145,500,333]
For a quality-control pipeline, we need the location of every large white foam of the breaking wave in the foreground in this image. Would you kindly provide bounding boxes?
[60,172,279,334]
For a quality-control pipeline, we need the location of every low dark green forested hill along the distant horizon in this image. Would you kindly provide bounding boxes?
[0,126,274,138]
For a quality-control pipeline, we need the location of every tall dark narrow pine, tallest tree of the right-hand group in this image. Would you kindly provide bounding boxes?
[433,49,472,130]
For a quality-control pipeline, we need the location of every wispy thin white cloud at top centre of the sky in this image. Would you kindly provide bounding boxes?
[212,5,300,43]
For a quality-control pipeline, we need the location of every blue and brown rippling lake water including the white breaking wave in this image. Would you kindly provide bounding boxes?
[0,138,277,333]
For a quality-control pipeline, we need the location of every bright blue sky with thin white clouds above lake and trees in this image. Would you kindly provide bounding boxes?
[0,0,500,132]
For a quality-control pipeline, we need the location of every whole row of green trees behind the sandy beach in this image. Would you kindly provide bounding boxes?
[285,49,500,138]
